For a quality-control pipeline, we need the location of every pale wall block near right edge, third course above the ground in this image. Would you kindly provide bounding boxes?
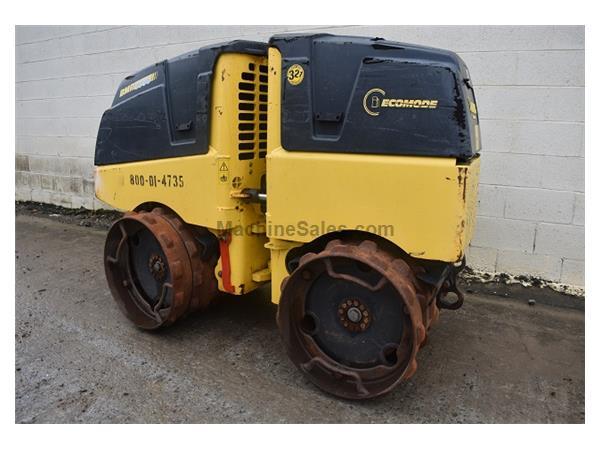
[505,188,575,223]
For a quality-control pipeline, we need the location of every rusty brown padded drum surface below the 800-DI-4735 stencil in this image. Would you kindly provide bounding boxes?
[104,208,217,329]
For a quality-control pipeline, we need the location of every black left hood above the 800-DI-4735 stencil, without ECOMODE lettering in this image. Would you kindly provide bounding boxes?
[94,41,267,166]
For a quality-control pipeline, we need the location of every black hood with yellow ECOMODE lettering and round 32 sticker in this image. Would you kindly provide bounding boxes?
[270,34,479,159]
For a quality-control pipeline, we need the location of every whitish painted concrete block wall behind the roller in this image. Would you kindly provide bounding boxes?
[15,26,585,286]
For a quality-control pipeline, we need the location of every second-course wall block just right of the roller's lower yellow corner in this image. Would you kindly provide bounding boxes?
[472,217,535,251]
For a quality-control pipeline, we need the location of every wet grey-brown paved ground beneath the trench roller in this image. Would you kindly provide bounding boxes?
[15,215,584,423]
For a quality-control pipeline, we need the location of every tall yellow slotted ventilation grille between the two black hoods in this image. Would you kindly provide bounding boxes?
[238,63,268,160]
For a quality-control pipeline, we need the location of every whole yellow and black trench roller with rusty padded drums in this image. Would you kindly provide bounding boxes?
[95,34,481,399]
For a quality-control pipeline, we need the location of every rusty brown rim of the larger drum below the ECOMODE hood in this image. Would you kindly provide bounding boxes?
[278,239,440,399]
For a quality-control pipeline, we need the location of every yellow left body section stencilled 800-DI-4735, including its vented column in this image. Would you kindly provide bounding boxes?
[96,53,269,294]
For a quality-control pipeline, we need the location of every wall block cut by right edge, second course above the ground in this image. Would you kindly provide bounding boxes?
[534,223,585,259]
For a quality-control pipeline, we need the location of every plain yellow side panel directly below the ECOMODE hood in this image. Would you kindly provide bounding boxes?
[267,148,479,262]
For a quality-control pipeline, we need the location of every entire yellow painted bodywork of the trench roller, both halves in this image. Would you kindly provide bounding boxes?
[95,48,479,303]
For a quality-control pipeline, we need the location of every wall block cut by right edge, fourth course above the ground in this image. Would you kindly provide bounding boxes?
[541,156,585,192]
